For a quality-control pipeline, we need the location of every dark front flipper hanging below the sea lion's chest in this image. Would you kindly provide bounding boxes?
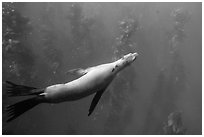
[88,87,106,116]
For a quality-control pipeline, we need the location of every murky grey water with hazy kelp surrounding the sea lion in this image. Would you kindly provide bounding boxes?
[2,2,202,135]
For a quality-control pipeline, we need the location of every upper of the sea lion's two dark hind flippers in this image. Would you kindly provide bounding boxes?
[6,81,44,96]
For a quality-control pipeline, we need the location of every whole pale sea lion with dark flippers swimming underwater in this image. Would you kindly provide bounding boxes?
[6,53,138,121]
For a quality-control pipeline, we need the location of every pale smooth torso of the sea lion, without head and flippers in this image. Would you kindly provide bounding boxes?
[44,62,117,103]
